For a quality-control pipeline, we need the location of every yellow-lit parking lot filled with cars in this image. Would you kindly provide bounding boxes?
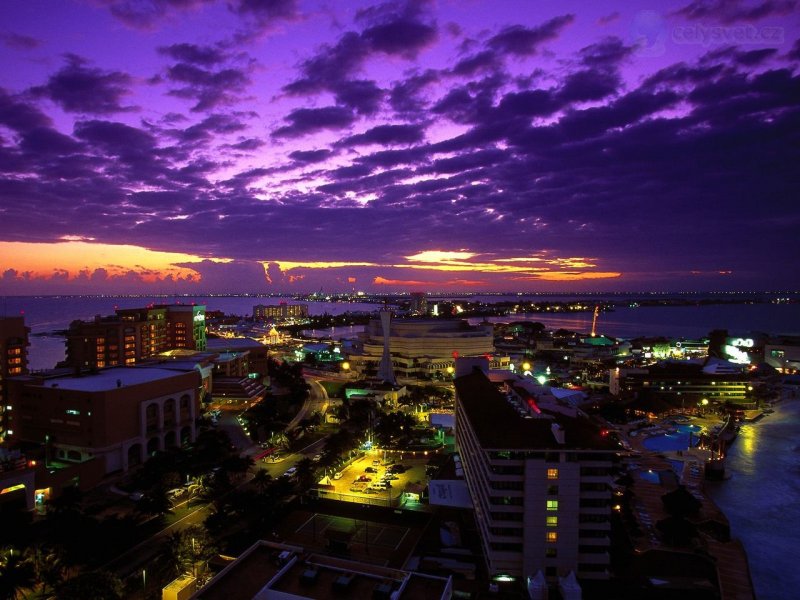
[320,452,428,506]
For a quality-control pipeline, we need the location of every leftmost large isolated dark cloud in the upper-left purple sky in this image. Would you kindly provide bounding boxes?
[31,54,136,115]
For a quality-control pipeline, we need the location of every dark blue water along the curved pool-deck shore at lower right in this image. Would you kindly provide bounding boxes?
[706,399,800,600]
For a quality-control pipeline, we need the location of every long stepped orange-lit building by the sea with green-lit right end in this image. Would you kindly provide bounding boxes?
[65,304,206,369]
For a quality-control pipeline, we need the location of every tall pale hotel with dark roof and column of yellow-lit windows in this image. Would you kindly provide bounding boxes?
[455,370,615,583]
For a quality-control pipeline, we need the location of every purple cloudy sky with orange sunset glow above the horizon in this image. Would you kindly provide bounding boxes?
[0,0,800,294]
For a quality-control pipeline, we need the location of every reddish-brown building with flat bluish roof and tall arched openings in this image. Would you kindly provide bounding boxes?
[9,367,200,473]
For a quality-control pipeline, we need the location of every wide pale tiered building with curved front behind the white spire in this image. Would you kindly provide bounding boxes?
[347,319,509,379]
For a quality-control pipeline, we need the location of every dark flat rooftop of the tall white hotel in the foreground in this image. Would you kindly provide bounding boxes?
[455,371,616,450]
